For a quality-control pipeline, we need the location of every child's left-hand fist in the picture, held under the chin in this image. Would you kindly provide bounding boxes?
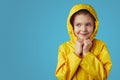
[75,40,83,56]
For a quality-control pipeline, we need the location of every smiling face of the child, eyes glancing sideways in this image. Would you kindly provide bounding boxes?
[73,14,94,40]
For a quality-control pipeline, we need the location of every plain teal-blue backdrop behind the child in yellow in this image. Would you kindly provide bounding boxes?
[0,0,120,80]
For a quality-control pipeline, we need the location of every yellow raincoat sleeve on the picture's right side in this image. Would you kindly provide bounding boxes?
[80,44,112,80]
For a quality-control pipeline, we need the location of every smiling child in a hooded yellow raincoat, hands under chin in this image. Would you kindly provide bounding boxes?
[56,4,112,80]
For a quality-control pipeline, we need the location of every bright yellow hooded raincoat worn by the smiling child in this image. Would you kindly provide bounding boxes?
[56,4,112,80]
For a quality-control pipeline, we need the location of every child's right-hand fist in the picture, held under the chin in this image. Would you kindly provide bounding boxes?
[83,39,92,56]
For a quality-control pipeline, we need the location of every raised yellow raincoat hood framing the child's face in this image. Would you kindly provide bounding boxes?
[67,4,98,42]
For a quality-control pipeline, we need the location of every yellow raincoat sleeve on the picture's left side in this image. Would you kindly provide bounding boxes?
[56,46,81,80]
